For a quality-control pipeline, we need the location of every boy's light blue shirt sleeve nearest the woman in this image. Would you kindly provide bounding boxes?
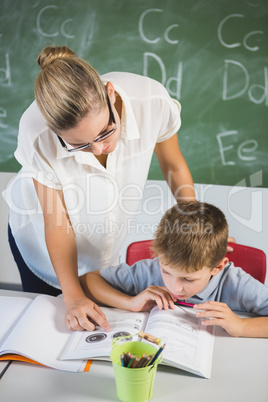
[100,258,165,296]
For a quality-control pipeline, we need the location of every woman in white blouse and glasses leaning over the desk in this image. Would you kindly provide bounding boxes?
[5,46,195,330]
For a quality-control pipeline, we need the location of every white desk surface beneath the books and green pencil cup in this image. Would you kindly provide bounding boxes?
[0,290,268,402]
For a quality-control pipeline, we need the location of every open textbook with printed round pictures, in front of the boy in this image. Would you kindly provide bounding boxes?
[61,306,214,378]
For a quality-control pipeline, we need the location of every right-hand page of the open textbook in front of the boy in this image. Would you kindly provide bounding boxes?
[145,306,214,378]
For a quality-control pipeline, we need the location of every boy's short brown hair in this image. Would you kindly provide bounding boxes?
[152,201,228,272]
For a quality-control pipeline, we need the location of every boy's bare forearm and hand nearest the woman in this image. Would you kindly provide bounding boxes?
[80,271,175,311]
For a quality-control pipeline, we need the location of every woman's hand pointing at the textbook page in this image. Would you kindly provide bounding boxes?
[65,297,110,331]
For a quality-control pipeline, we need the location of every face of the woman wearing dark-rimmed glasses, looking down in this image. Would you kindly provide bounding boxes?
[60,98,120,156]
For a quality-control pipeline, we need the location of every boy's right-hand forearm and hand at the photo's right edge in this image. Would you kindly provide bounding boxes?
[194,301,268,338]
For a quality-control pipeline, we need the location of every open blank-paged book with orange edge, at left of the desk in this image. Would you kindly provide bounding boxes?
[0,295,90,372]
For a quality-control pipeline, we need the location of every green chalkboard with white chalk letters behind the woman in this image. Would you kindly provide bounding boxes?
[0,0,268,187]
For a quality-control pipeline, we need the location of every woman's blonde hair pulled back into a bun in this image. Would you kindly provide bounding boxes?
[35,46,107,132]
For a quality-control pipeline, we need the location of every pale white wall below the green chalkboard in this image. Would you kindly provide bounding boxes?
[0,173,268,288]
